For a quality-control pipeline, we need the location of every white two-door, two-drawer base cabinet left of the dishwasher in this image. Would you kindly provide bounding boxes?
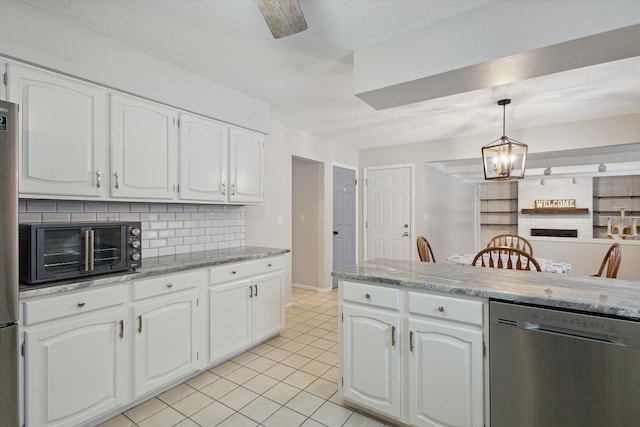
[340,282,486,427]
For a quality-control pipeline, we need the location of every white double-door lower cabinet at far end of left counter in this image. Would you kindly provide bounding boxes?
[209,257,285,363]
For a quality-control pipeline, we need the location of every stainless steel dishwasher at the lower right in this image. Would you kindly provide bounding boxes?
[489,301,640,427]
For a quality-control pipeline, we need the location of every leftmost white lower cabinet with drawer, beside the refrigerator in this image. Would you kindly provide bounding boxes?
[23,287,129,427]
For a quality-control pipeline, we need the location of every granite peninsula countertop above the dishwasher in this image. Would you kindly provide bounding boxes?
[332,259,640,319]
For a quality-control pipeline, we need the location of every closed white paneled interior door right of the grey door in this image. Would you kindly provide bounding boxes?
[365,166,413,260]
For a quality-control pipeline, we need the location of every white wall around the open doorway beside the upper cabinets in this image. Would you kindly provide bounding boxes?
[246,121,358,301]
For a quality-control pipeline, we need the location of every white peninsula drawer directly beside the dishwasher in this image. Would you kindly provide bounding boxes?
[407,292,484,326]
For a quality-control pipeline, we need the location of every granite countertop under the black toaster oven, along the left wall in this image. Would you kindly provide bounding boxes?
[19,246,290,298]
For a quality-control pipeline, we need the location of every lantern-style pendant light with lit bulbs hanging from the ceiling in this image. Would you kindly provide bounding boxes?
[482,99,527,181]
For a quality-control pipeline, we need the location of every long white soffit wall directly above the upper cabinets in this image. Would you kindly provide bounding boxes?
[0,0,271,133]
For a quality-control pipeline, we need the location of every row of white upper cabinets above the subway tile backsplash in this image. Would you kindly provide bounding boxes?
[6,62,264,204]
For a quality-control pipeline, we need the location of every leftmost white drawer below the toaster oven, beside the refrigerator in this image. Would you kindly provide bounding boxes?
[24,286,127,326]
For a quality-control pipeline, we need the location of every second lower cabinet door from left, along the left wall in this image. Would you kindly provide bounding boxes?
[133,290,198,398]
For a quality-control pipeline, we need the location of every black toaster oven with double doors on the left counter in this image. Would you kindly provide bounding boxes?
[19,222,142,284]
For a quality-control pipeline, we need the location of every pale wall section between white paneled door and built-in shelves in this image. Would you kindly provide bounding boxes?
[424,165,476,262]
